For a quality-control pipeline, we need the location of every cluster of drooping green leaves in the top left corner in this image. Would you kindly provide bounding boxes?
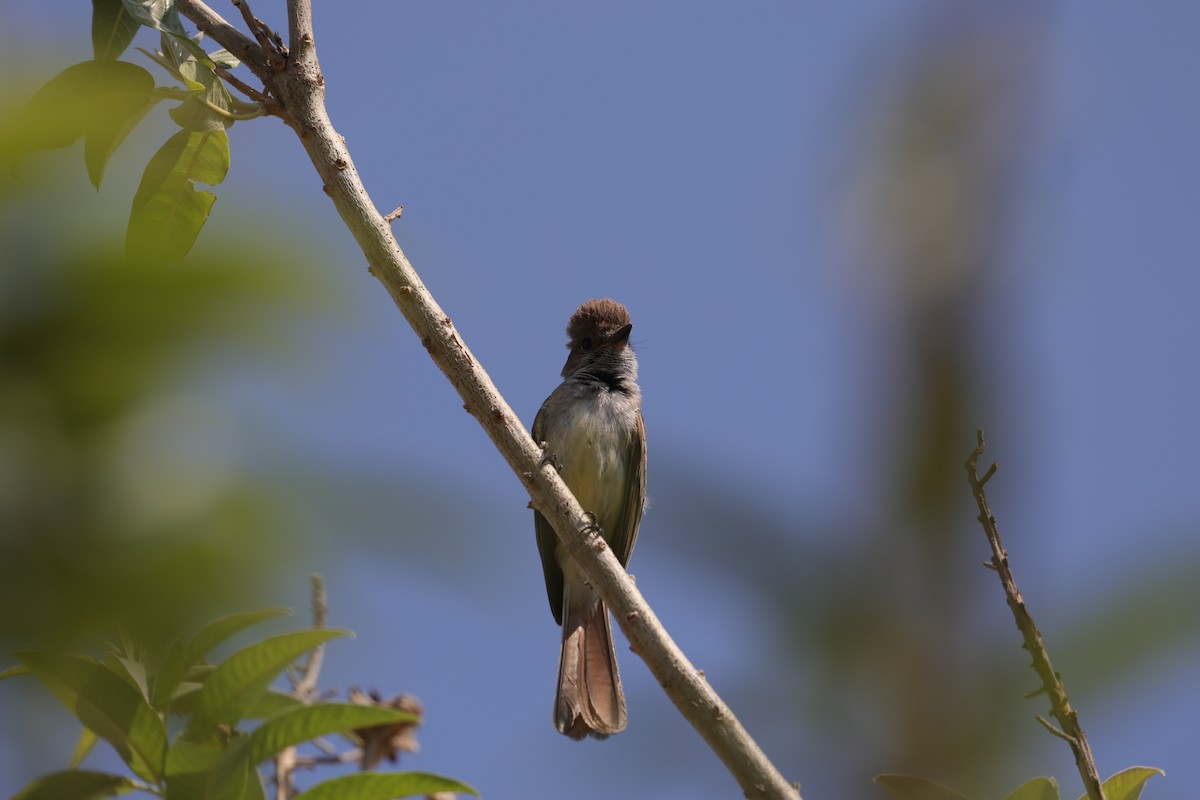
[2,0,265,261]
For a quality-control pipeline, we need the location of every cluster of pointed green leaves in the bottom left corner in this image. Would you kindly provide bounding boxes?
[0,608,475,800]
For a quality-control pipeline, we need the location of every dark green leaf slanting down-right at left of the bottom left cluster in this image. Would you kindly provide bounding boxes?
[14,650,167,781]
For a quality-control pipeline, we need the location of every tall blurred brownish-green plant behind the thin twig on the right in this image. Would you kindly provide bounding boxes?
[654,4,1200,796]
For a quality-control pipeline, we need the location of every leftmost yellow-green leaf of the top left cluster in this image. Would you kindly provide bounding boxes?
[16,61,155,156]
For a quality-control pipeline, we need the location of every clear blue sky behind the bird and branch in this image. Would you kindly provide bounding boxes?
[0,0,1200,800]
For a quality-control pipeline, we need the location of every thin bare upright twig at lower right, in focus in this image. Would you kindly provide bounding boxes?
[965,428,1106,800]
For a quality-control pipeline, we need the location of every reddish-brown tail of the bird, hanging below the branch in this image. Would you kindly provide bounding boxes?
[554,581,626,739]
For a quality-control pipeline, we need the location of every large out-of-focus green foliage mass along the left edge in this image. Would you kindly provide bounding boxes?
[0,81,337,646]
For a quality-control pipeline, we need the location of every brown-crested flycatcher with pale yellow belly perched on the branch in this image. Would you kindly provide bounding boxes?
[533,299,646,739]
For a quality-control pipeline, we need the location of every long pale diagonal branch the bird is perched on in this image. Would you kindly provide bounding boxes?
[179,0,800,800]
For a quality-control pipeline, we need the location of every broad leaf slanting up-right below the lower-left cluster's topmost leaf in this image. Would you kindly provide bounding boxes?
[187,630,349,739]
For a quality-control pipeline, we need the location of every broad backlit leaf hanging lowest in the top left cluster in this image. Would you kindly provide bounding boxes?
[125,130,229,263]
